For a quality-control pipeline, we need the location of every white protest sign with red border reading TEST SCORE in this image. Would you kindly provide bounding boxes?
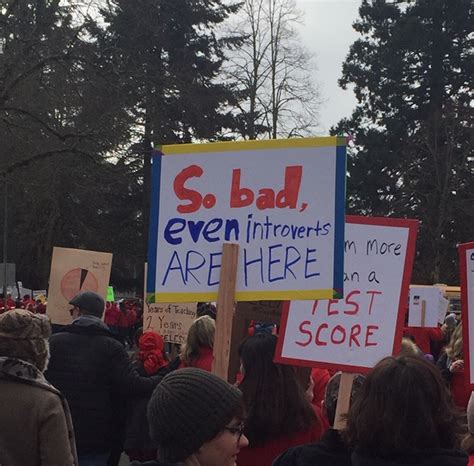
[275,216,418,372]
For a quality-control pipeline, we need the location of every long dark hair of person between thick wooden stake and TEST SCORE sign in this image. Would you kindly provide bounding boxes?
[239,333,316,447]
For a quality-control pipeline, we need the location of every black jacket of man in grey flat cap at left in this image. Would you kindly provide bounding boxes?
[45,322,162,455]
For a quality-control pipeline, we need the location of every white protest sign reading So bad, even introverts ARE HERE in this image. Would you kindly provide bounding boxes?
[147,137,345,302]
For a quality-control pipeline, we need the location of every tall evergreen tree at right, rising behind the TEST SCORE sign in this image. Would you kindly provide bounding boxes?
[334,0,474,283]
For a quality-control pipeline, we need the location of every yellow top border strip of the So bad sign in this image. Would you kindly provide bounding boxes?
[156,136,346,155]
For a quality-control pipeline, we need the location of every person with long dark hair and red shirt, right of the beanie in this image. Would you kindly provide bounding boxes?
[237,333,329,466]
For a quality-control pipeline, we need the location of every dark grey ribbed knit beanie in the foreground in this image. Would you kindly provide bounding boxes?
[148,368,242,463]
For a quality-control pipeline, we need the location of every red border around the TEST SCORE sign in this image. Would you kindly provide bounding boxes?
[274,215,418,373]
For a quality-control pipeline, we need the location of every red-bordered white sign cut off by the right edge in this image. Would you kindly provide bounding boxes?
[459,242,474,390]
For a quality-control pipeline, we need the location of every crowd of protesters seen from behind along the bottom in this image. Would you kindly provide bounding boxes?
[0,292,474,466]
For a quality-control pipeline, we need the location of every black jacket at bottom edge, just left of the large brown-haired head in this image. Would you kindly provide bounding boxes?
[272,429,352,466]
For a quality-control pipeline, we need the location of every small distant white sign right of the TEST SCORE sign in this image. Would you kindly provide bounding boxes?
[408,285,449,327]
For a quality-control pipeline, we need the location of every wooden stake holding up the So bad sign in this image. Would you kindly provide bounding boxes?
[212,243,239,380]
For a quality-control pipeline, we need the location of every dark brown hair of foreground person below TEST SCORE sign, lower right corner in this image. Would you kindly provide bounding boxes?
[345,356,460,456]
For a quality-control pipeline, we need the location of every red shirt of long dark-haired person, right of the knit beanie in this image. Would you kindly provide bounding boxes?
[237,406,329,466]
